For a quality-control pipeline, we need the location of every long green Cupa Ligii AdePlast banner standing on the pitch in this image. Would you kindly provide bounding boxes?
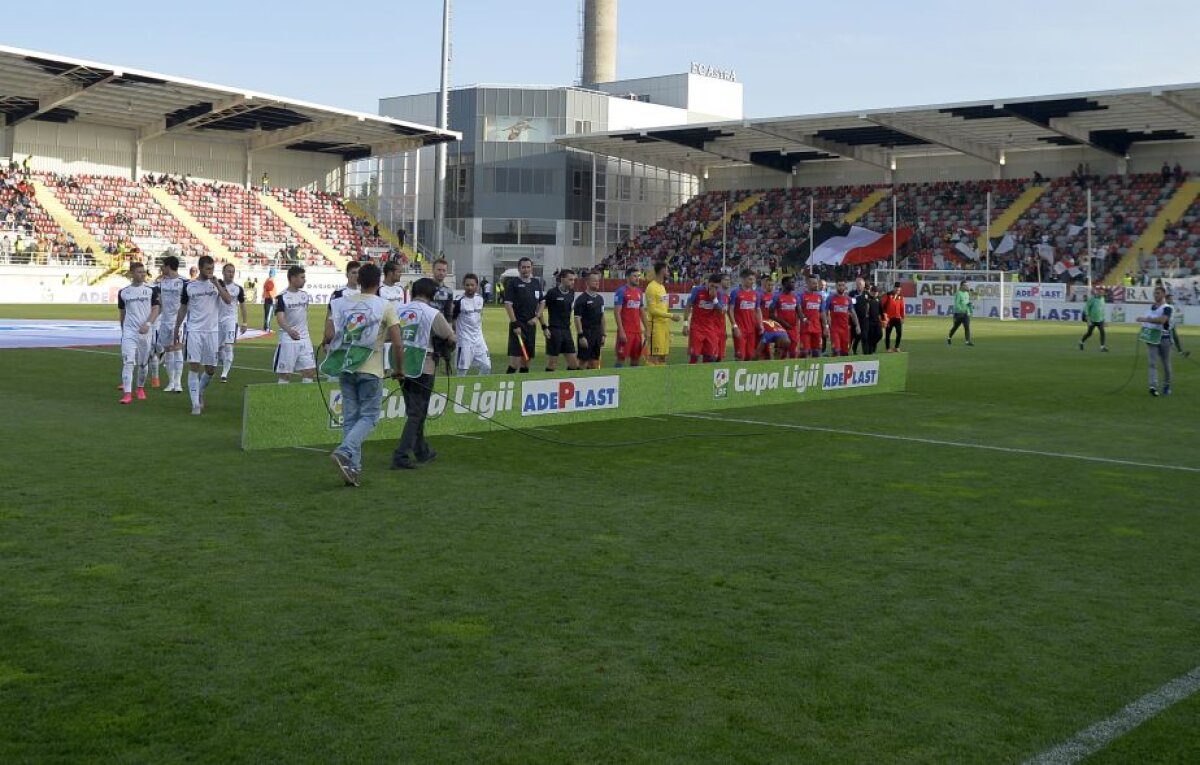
[241,354,908,450]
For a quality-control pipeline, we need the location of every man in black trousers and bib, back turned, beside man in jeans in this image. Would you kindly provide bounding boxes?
[391,277,458,470]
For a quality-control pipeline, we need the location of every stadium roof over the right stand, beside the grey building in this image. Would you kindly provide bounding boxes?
[556,84,1200,175]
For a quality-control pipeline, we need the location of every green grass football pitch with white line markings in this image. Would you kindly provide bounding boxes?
[0,306,1200,764]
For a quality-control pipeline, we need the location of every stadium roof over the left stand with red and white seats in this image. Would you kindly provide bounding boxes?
[0,46,462,161]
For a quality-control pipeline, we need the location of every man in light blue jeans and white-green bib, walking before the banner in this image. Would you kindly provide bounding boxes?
[322,264,402,486]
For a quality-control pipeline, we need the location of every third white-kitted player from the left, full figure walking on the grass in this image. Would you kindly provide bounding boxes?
[175,255,233,415]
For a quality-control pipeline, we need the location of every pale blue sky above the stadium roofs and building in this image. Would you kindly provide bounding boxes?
[9,0,1200,116]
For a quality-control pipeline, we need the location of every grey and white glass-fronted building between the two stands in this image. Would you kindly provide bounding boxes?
[376,66,743,277]
